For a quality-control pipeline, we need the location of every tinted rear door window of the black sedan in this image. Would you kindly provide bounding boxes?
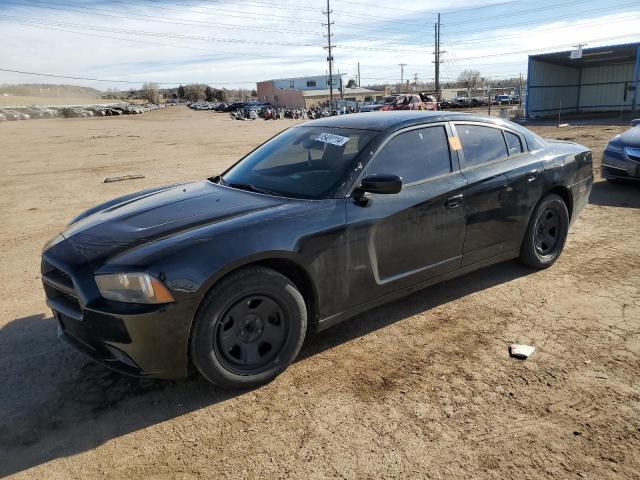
[456,124,508,167]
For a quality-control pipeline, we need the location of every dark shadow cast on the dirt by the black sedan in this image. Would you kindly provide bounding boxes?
[0,262,532,477]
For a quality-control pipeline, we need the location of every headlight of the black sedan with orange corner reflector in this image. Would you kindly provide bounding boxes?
[96,273,173,303]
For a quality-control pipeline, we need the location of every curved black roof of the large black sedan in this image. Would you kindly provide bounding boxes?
[297,110,527,132]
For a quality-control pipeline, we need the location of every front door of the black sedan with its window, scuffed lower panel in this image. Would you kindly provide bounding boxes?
[346,123,466,305]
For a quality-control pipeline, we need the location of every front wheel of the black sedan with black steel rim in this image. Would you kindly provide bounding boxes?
[190,267,307,389]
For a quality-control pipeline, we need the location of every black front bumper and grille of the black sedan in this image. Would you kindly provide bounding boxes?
[42,248,199,379]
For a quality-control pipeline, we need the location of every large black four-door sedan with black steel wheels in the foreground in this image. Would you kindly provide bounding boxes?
[42,111,593,388]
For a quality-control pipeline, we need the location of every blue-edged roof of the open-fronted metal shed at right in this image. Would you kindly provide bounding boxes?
[529,43,640,68]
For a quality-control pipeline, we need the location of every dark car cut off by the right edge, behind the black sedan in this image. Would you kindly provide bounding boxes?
[602,125,640,182]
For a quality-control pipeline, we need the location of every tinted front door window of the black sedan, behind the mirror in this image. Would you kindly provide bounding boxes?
[367,126,451,184]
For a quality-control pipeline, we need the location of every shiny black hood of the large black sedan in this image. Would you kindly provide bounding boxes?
[62,181,286,263]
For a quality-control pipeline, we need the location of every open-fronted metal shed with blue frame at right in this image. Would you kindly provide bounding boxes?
[526,43,640,118]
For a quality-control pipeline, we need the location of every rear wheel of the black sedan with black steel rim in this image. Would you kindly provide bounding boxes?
[520,194,569,270]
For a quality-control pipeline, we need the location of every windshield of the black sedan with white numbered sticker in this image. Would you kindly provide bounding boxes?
[222,127,377,199]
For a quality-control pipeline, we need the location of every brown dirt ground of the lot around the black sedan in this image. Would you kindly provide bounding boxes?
[0,107,640,479]
